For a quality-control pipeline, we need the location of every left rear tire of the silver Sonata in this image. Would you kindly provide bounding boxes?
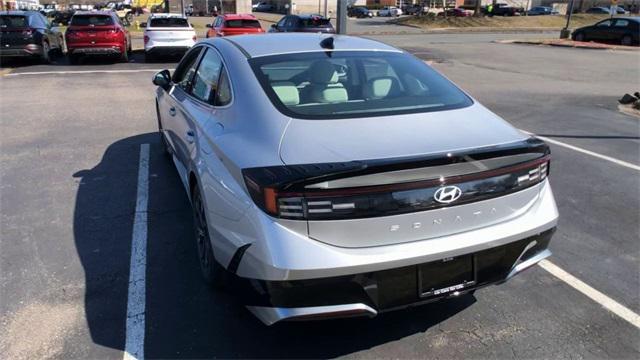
[191,184,226,288]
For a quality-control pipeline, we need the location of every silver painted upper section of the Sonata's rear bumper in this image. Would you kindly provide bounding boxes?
[229,180,558,281]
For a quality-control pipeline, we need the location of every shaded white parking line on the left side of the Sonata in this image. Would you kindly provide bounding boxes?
[123,144,149,360]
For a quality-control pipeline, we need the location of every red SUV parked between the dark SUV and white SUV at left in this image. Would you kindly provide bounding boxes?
[65,11,131,64]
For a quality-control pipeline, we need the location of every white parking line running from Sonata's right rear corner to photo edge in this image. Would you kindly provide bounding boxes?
[538,260,640,328]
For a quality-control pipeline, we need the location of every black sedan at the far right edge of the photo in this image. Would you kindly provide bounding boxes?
[571,16,640,45]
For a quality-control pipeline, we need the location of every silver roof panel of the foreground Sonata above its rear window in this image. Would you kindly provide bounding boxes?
[218,33,402,58]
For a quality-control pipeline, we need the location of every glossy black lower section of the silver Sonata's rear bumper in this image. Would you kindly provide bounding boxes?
[241,228,555,325]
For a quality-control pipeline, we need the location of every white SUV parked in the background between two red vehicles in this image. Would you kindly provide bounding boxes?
[143,13,197,61]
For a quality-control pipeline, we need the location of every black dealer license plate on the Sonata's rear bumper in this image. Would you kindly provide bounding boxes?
[418,255,476,297]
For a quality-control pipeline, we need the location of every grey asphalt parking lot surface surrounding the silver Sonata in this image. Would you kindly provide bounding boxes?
[0,29,640,359]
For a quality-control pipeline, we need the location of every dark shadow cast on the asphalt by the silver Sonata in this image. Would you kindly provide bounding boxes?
[74,133,475,358]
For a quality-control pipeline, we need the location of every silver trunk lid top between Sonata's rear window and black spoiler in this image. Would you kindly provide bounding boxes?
[280,102,528,165]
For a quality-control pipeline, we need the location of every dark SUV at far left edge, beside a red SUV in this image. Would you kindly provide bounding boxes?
[0,10,64,63]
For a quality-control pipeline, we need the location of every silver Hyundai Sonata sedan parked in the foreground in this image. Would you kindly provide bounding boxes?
[153,34,558,324]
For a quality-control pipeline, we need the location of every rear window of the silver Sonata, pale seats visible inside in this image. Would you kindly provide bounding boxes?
[250,51,472,119]
